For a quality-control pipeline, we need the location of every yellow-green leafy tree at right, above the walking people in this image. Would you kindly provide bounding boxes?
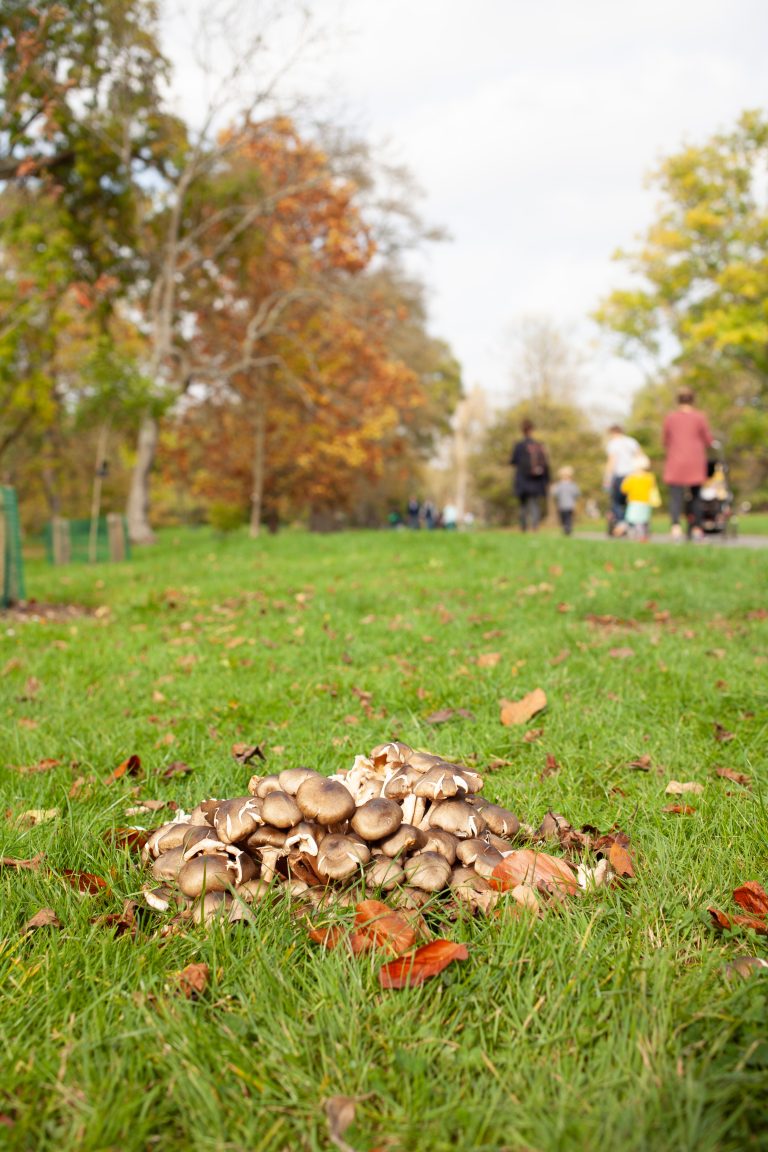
[596,112,768,497]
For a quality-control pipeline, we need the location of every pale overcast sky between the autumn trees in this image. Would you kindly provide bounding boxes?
[158,0,768,415]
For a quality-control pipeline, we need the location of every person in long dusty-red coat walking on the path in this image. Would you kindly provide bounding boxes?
[662,387,714,540]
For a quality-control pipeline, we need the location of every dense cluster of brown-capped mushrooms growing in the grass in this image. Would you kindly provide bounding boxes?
[138,742,534,923]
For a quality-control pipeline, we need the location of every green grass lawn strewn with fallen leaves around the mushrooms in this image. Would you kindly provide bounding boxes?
[0,529,768,1152]
